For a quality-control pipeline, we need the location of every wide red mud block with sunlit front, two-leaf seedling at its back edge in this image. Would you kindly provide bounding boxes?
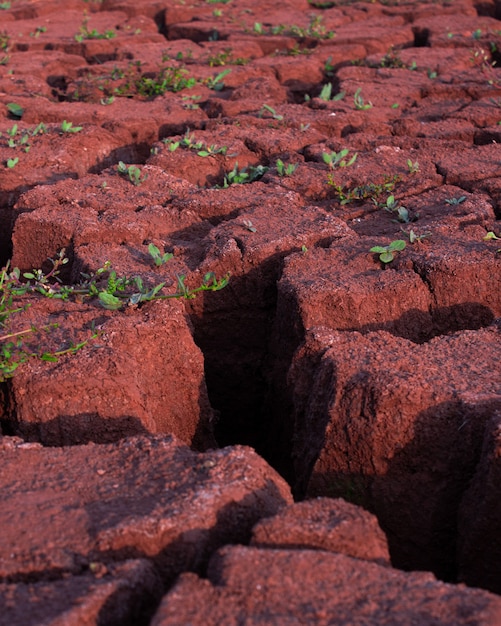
[277,225,501,346]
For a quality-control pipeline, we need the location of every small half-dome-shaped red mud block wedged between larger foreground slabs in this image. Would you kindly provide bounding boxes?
[251,498,390,565]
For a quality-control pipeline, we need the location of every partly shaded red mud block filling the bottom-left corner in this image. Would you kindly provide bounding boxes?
[0,559,162,626]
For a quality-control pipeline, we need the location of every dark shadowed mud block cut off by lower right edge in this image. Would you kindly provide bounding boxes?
[458,413,501,594]
